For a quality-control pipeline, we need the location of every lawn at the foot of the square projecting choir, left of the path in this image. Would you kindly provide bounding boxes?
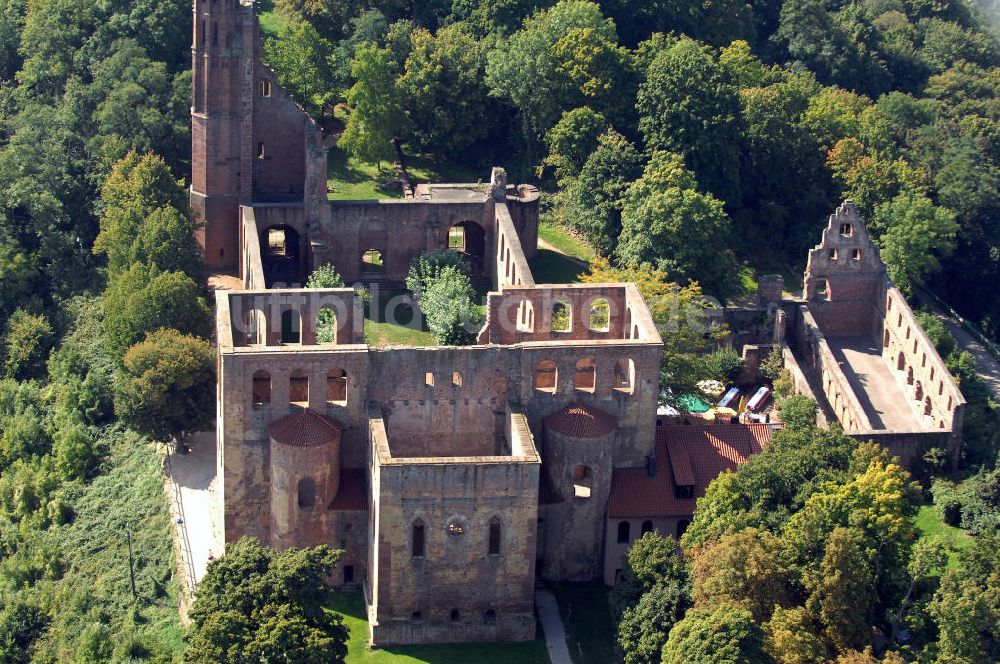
[330,593,549,664]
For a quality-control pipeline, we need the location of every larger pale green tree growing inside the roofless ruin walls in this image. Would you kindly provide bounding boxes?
[420,266,483,346]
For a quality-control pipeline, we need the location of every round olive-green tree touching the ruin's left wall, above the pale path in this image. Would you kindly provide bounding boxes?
[115,329,215,442]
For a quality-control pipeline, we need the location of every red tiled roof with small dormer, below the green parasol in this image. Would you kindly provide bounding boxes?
[608,424,771,518]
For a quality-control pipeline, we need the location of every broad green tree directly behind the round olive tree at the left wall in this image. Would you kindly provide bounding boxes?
[104,263,213,358]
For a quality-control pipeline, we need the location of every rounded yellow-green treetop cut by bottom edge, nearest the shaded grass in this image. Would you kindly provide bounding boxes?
[661,604,770,664]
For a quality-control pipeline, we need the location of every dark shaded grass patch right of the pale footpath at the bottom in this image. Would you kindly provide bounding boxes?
[554,585,618,664]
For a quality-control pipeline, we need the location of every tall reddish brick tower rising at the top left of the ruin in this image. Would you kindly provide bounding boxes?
[191,0,246,269]
